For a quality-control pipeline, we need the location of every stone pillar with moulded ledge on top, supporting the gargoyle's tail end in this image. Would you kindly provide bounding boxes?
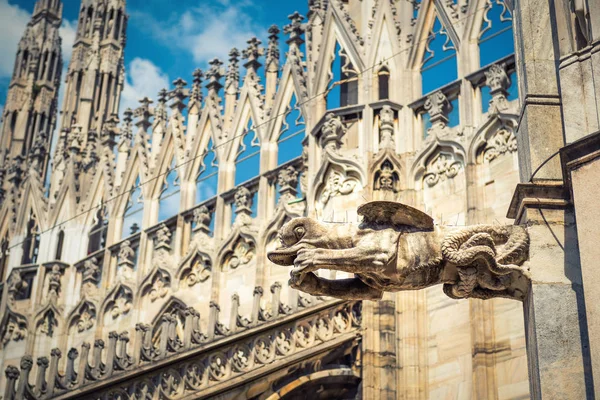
[509,184,594,399]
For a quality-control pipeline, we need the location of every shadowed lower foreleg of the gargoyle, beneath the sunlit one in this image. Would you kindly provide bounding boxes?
[289,272,383,300]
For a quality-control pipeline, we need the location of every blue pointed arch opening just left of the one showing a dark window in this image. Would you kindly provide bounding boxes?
[277,94,306,165]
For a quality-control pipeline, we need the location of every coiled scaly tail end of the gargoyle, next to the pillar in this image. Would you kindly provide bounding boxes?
[442,225,529,299]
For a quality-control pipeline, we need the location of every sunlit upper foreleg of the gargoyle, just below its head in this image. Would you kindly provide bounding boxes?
[293,247,396,273]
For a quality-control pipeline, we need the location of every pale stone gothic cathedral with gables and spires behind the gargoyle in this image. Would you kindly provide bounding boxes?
[0,0,600,400]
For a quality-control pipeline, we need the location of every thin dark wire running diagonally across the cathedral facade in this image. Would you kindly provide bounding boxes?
[7,3,500,250]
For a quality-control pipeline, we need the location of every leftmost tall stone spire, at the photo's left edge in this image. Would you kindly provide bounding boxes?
[0,0,63,180]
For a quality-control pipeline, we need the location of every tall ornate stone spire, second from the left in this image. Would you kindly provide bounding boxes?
[61,0,128,145]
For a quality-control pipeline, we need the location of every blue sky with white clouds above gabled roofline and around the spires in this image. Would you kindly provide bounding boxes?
[0,0,308,115]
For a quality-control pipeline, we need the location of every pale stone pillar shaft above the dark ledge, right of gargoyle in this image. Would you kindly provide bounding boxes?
[513,0,564,182]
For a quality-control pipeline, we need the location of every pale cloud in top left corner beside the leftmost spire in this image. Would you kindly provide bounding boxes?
[0,0,31,77]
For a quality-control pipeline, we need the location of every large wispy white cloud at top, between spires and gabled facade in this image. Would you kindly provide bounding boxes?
[131,0,266,64]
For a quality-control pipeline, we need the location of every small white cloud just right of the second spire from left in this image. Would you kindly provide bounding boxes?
[120,58,170,113]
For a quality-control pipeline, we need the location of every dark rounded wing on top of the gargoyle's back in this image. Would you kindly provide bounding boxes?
[358,201,433,230]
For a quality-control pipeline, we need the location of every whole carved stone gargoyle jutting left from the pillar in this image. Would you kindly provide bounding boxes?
[268,201,530,300]
